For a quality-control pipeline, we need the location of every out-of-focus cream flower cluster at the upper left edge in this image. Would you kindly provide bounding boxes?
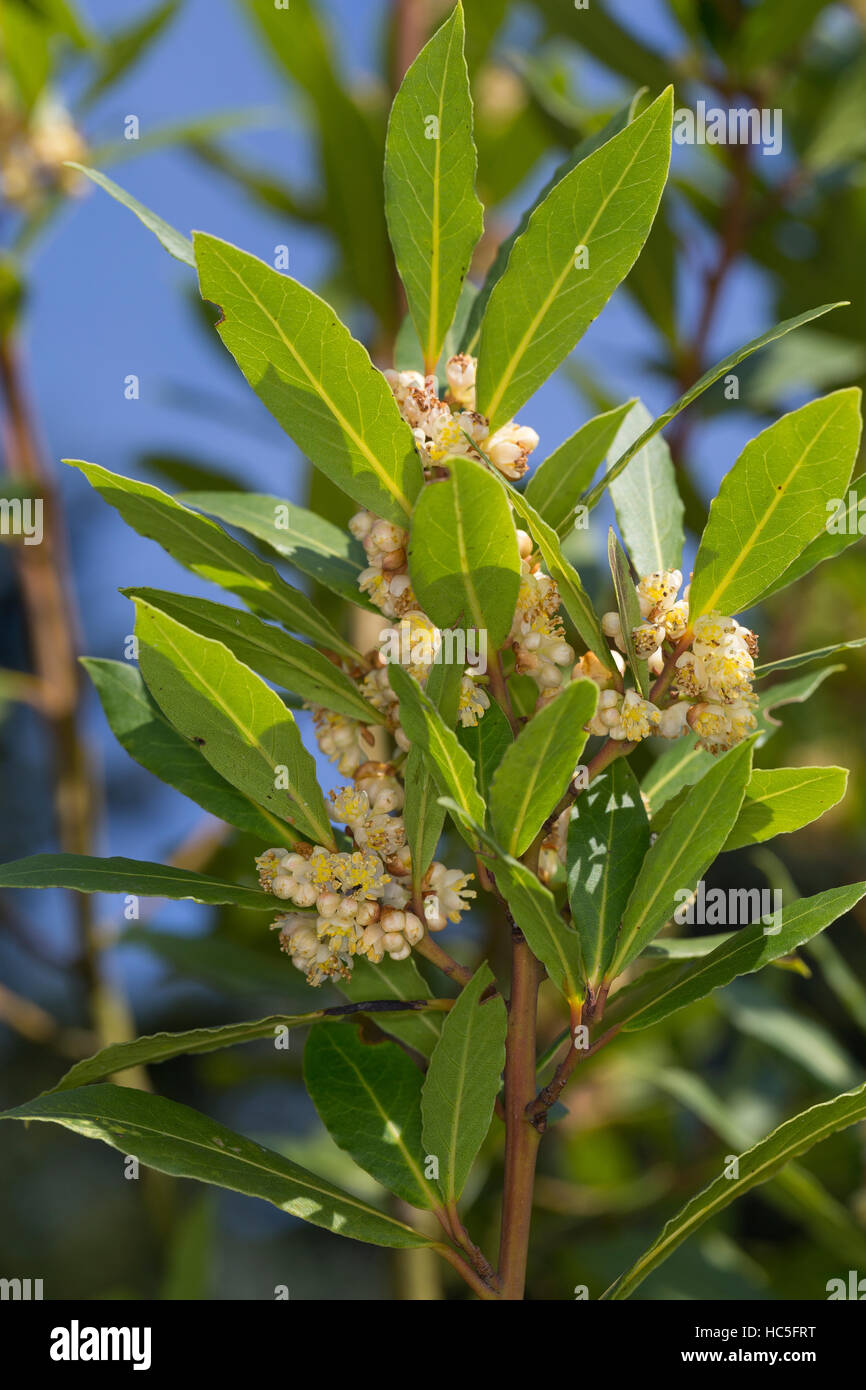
[0,101,86,211]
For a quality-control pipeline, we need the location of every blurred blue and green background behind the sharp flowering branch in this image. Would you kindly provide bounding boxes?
[0,0,866,1300]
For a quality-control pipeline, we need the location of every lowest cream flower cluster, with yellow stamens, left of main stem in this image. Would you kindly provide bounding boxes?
[256,763,475,986]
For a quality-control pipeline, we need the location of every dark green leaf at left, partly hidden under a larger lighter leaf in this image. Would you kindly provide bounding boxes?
[82,657,285,844]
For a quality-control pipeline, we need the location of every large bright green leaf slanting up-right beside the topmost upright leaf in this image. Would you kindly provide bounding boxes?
[477,88,673,428]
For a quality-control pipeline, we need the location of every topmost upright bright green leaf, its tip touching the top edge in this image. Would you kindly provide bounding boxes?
[385,4,484,373]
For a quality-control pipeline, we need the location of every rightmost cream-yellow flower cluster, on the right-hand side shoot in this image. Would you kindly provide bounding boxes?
[588,570,758,753]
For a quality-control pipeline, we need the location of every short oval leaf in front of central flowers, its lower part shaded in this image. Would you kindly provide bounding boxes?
[409,459,520,651]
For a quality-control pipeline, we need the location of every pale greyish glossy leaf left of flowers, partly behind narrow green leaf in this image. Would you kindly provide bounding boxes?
[179,489,371,606]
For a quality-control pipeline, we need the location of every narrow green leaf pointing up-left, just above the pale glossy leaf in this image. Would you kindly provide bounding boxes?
[64,459,357,662]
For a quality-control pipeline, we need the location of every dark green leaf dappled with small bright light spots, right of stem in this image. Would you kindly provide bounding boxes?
[566,758,649,988]
